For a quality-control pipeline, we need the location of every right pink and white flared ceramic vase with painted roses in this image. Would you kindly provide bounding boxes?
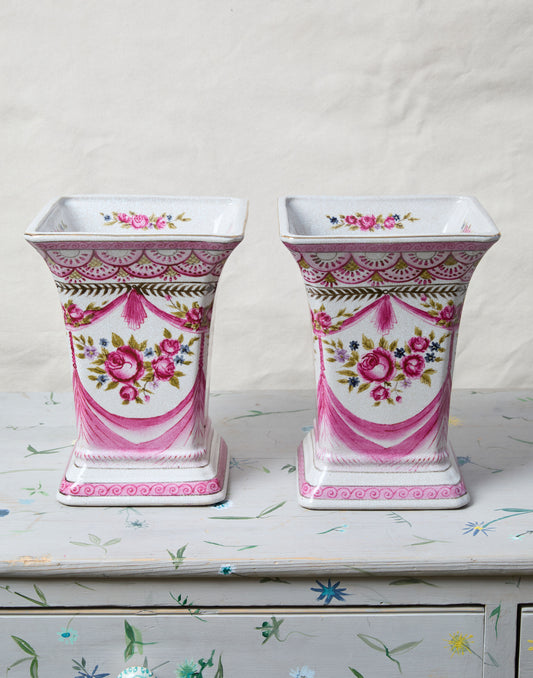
[279,196,499,509]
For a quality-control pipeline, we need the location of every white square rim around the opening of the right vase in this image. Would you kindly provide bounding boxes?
[278,193,501,244]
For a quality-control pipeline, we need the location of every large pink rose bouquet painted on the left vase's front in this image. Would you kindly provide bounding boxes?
[73,328,198,405]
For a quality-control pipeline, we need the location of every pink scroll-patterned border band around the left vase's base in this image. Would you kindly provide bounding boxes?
[59,438,228,497]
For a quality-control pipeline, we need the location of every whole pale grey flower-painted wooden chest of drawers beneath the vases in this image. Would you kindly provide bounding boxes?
[0,391,533,678]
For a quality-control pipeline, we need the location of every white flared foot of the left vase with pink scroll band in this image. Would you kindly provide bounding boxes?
[57,433,229,506]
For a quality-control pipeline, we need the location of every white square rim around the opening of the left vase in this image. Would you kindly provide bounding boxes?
[24,193,249,243]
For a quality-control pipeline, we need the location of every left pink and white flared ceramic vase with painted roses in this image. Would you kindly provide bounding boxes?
[26,196,247,506]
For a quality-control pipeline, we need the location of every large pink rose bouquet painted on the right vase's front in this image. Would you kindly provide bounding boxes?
[323,327,450,406]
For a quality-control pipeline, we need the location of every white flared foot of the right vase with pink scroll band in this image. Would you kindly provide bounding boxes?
[298,431,470,510]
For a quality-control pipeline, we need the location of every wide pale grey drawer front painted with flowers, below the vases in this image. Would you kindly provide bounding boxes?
[0,608,484,678]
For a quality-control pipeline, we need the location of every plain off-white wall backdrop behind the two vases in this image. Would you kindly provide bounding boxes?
[0,0,533,391]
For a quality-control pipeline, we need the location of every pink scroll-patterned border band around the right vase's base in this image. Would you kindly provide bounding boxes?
[298,443,466,501]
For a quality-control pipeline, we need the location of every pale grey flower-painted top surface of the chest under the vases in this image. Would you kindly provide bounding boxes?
[0,390,533,577]
